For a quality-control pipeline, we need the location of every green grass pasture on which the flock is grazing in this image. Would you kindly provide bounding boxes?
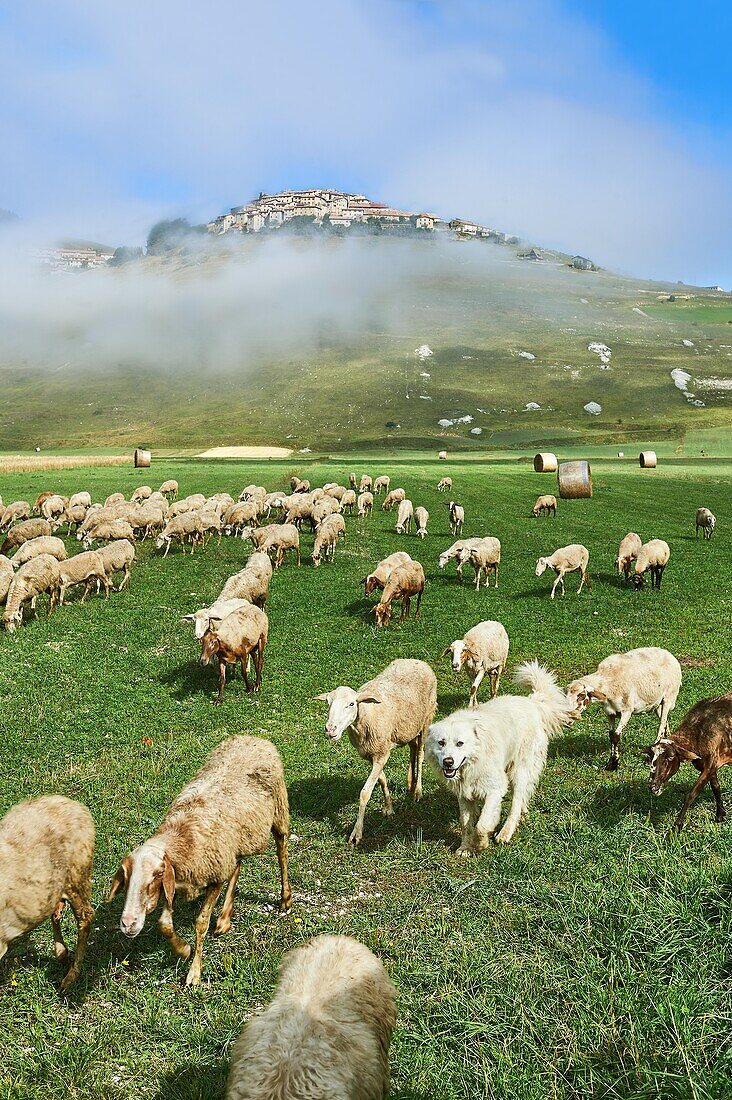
[0,448,732,1100]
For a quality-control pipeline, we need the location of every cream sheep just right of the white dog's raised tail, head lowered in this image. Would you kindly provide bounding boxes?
[567,646,681,771]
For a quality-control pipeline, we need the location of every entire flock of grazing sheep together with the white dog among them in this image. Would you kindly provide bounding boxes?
[0,474,732,1100]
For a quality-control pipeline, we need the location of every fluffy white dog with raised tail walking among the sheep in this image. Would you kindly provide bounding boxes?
[426,661,575,857]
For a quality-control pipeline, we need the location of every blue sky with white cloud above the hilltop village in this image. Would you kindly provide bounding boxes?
[0,0,732,285]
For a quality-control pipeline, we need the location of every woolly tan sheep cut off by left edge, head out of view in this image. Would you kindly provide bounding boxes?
[0,794,95,993]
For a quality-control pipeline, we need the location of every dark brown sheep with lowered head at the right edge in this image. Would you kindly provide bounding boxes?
[646,692,732,832]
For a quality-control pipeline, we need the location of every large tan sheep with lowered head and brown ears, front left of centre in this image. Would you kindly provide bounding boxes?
[109,735,292,986]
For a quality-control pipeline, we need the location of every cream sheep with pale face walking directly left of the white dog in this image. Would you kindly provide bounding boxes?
[317,659,437,845]
